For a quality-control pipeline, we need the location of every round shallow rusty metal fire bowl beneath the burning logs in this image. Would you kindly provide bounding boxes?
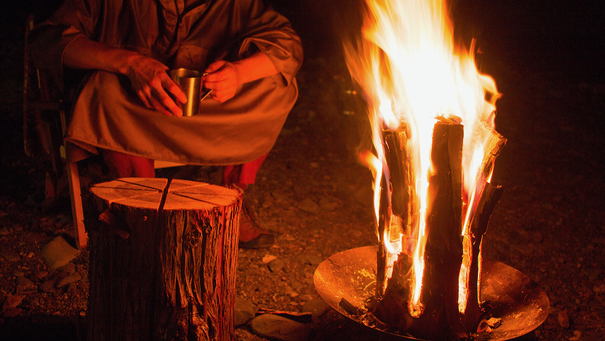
[313,246,550,340]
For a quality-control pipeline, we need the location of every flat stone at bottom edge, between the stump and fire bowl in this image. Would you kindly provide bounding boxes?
[250,314,311,341]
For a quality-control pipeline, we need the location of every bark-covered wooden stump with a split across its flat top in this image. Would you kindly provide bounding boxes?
[87,178,241,341]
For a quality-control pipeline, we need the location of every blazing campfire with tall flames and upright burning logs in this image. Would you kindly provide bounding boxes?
[316,0,544,340]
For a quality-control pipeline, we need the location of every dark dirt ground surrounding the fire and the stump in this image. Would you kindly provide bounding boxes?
[0,0,605,341]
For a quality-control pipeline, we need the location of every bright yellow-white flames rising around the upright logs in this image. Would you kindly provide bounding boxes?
[344,0,499,317]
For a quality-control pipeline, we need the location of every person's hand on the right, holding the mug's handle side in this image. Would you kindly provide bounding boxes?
[203,60,239,103]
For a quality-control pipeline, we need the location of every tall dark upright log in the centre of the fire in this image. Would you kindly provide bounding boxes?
[410,121,464,340]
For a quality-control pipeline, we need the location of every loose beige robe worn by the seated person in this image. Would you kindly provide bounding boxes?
[30,0,302,165]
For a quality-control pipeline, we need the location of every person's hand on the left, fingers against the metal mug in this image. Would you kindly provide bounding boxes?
[126,54,187,116]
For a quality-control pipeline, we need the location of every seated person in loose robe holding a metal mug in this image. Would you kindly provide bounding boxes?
[29,0,303,247]
